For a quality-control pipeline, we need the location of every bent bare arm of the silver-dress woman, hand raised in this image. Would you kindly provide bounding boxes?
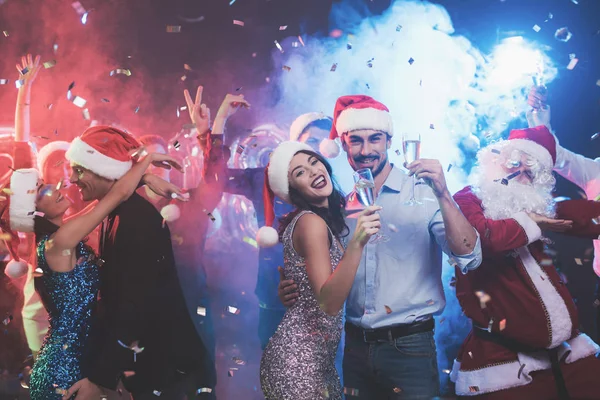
[292,206,381,315]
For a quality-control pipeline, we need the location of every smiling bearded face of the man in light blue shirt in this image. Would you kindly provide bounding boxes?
[342,129,392,177]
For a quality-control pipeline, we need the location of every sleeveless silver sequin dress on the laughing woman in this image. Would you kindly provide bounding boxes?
[260,211,343,400]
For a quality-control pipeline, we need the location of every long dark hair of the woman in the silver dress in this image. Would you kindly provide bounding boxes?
[279,150,349,241]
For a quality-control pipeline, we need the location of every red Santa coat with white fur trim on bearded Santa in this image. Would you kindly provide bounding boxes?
[451,187,600,396]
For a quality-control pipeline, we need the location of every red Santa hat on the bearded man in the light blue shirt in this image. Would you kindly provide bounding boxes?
[319,95,394,158]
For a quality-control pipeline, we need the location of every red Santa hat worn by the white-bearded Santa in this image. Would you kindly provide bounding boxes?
[508,125,556,169]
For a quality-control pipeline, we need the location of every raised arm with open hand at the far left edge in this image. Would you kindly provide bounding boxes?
[13,54,40,169]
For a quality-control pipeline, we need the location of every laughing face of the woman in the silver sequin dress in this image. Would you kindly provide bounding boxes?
[288,153,333,207]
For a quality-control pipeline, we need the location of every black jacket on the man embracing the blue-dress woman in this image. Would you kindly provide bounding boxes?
[89,193,207,393]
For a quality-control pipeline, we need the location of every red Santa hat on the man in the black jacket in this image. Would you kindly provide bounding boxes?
[65,125,141,180]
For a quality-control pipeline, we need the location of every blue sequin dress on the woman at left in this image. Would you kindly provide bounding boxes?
[29,236,100,400]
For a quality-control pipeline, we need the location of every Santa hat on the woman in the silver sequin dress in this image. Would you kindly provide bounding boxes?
[256,141,314,247]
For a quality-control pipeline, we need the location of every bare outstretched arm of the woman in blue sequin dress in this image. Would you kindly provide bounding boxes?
[46,153,181,270]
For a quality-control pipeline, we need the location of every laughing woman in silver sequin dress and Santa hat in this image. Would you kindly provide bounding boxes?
[258,142,380,400]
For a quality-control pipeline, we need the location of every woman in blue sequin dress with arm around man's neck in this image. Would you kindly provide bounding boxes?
[9,153,180,400]
